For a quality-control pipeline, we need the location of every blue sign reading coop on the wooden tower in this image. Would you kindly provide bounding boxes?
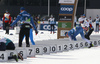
[60,5,74,14]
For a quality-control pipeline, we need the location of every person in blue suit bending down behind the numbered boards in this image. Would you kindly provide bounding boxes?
[65,26,92,48]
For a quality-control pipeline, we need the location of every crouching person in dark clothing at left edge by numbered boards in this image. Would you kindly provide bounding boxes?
[0,38,23,62]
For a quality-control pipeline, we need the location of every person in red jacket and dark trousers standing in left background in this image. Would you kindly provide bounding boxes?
[3,11,11,34]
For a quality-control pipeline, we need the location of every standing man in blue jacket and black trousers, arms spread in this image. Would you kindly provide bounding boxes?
[11,7,38,47]
